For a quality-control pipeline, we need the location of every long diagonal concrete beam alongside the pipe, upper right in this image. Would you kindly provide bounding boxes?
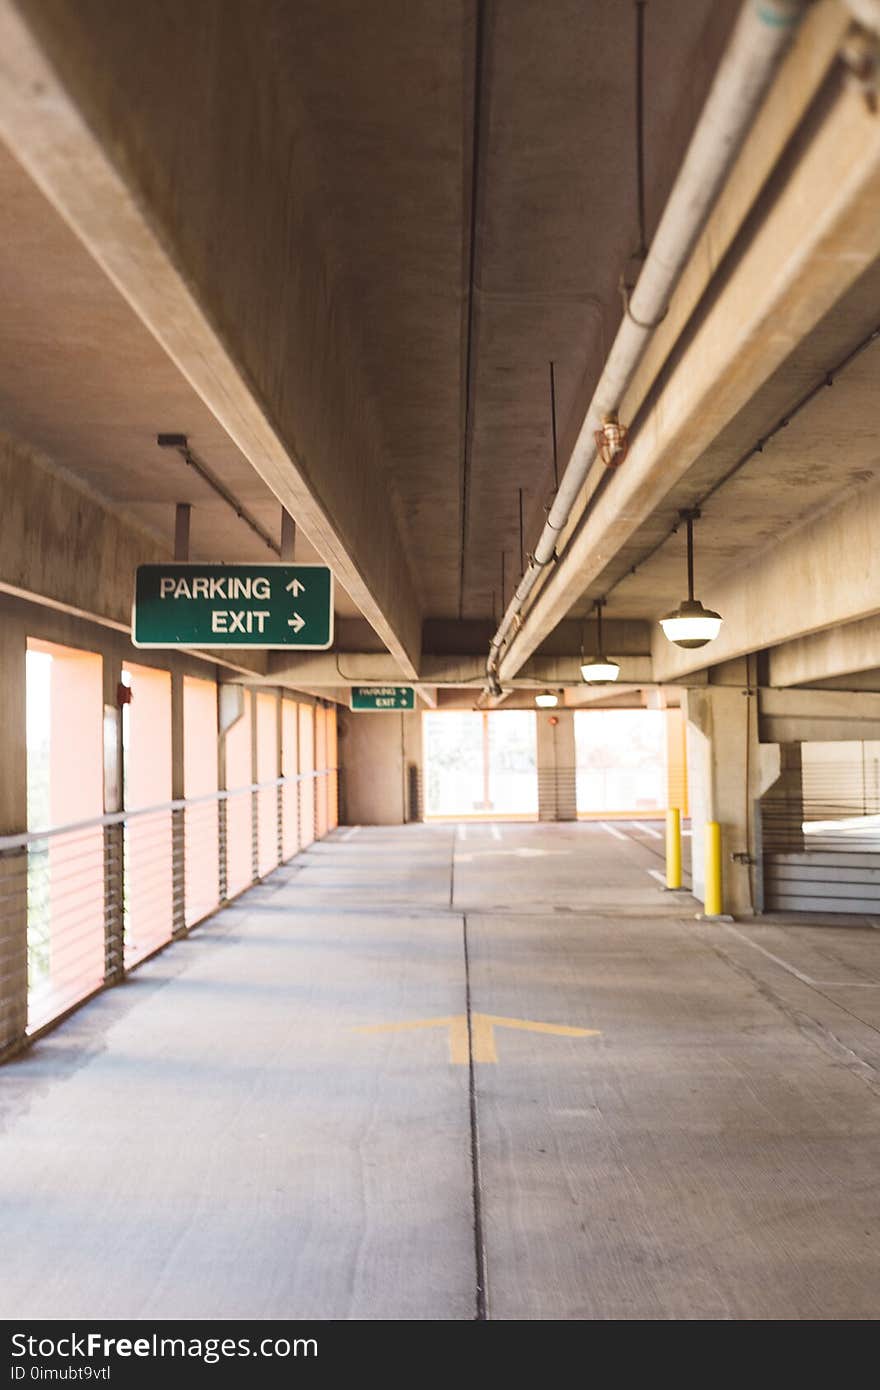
[500,52,880,681]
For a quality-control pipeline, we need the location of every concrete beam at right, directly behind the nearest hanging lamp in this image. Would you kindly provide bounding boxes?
[653,469,880,685]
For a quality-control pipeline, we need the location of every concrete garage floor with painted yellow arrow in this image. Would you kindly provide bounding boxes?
[0,823,880,1319]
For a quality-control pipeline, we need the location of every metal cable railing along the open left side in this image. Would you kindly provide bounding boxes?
[0,767,338,1056]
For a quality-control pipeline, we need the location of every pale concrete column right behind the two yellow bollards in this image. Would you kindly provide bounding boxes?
[685,671,762,916]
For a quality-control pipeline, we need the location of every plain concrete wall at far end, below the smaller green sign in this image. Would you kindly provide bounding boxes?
[339,710,421,826]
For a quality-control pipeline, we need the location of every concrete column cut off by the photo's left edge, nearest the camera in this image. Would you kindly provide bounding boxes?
[0,617,28,1056]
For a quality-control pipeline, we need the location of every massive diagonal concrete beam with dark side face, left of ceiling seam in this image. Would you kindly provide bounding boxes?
[0,0,421,676]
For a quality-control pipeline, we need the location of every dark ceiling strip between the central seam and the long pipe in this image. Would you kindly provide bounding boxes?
[445,0,737,616]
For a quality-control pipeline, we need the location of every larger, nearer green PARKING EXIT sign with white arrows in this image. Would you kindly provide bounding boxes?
[132,562,334,652]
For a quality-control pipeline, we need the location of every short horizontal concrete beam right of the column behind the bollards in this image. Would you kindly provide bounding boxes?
[758,689,880,744]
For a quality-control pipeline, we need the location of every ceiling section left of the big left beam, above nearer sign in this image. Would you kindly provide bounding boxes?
[0,145,357,616]
